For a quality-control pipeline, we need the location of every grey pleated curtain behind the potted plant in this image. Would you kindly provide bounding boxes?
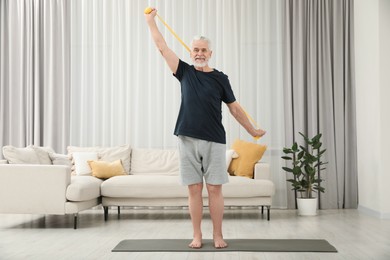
[283,0,358,208]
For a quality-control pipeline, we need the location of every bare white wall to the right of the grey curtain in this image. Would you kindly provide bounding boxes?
[355,0,390,218]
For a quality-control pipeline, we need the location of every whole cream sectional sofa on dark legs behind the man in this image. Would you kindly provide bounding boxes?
[0,146,275,229]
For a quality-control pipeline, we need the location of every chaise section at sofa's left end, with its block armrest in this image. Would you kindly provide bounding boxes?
[0,162,103,229]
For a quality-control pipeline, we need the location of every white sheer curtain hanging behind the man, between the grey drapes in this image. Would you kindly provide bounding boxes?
[70,0,287,207]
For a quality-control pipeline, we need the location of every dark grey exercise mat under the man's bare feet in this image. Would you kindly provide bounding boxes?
[112,239,337,253]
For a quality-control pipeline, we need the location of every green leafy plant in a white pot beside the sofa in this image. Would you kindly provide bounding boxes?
[282,132,326,216]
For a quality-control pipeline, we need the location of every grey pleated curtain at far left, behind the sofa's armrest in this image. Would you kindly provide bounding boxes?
[0,0,70,152]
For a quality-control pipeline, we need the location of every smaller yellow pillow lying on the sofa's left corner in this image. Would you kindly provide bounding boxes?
[88,160,126,179]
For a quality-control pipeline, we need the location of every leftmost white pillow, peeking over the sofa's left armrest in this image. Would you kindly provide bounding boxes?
[3,145,40,164]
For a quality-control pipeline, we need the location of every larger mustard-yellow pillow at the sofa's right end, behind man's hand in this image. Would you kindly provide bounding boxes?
[228,140,267,178]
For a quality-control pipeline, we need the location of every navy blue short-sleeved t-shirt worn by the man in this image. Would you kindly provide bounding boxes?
[174,60,236,144]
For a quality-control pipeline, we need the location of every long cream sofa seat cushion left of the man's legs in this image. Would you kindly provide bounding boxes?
[101,175,187,198]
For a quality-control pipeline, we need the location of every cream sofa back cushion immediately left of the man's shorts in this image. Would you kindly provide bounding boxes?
[130,148,179,175]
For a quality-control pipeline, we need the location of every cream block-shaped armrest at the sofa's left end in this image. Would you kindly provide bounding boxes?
[0,164,70,214]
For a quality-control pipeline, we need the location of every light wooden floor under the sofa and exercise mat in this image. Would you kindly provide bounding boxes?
[0,208,390,260]
